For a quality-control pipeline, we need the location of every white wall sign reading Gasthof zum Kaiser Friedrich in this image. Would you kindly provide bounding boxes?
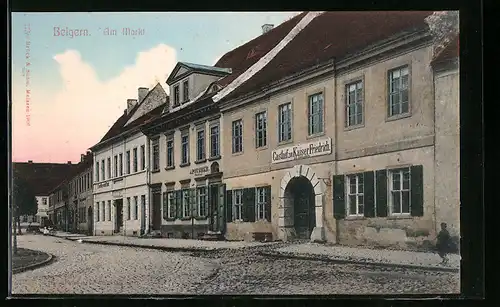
[271,138,332,163]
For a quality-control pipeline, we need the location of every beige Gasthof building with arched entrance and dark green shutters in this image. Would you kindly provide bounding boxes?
[209,12,458,247]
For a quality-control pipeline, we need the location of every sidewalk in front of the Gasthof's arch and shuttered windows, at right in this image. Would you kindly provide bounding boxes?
[262,243,460,272]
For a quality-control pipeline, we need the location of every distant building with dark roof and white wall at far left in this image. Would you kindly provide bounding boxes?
[12,160,75,223]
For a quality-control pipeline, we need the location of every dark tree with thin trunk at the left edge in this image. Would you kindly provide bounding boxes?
[12,170,37,252]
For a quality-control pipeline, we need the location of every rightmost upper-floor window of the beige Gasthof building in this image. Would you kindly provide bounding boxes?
[387,65,410,118]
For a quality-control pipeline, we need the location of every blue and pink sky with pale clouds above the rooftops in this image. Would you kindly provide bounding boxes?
[11,12,298,163]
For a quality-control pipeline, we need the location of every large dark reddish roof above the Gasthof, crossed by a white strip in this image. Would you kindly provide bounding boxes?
[216,11,432,100]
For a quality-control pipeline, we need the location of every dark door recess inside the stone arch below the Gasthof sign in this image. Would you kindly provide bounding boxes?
[284,176,316,240]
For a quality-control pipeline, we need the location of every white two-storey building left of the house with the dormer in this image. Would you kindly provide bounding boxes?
[91,84,168,236]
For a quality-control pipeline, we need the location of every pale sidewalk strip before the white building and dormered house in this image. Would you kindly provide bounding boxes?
[49,231,282,252]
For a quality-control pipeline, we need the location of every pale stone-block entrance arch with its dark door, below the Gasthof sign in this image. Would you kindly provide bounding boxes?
[278,165,325,242]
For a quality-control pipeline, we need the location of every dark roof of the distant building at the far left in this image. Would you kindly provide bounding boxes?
[12,162,78,196]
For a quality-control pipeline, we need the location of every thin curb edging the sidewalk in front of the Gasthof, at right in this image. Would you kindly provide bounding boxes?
[258,252,459,273]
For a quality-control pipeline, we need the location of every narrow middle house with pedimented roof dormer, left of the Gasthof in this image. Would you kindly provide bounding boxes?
[143,63,230,238]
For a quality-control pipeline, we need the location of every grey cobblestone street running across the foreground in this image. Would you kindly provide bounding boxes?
[12,235,460,295]
